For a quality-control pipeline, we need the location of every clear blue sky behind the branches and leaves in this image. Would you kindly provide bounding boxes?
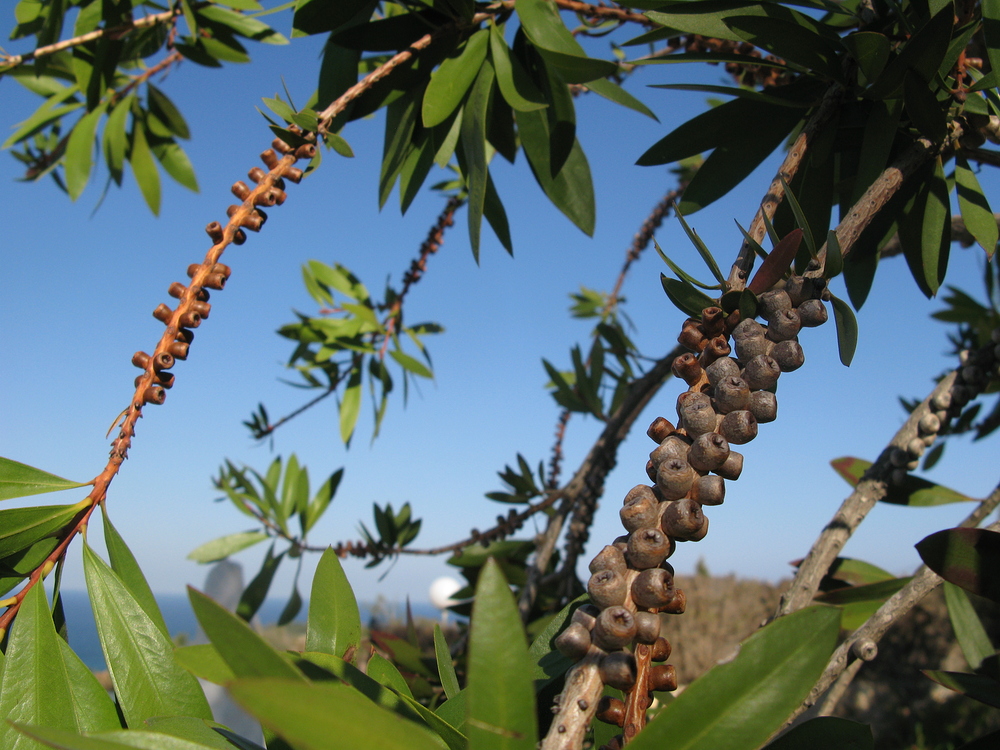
[0,7,1000,616]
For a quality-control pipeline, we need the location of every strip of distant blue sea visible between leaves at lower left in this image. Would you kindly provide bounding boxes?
[63,591,440,671]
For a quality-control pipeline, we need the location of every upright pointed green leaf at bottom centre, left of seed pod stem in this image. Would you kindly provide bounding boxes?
[467,559,538,750]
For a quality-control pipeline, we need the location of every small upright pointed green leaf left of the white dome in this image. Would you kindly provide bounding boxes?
[306,548,361,661]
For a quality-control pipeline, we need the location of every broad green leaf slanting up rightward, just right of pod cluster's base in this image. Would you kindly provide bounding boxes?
[630,607,840,750]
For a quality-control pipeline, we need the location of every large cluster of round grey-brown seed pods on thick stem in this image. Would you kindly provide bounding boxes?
[555,276,828,750]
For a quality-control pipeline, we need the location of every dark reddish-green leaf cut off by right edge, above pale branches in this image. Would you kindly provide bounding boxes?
[916,529,1000,602]
